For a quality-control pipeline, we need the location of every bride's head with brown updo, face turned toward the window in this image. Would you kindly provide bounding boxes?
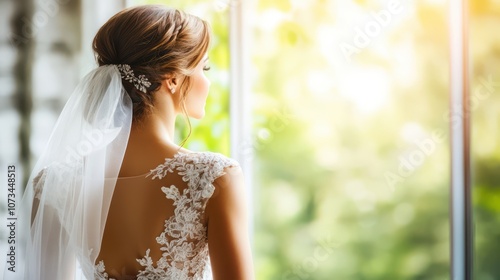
[93,5,210,121]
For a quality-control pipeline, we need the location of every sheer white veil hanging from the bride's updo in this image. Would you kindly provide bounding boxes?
[4,65,133,280]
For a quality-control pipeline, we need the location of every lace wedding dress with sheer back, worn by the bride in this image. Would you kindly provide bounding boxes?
[34,152,238,280]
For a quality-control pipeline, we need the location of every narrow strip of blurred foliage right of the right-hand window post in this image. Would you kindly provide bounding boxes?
[470,0,500,280]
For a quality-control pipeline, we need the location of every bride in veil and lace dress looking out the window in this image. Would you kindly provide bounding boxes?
[9,5,254,280]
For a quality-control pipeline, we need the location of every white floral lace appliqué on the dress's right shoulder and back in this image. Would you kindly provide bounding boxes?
[94,152,238,280]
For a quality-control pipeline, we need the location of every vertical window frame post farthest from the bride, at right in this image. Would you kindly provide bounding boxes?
[448,0,474,280]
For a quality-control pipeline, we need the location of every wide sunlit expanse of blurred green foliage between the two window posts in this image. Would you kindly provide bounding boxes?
[253,1,450,280]
